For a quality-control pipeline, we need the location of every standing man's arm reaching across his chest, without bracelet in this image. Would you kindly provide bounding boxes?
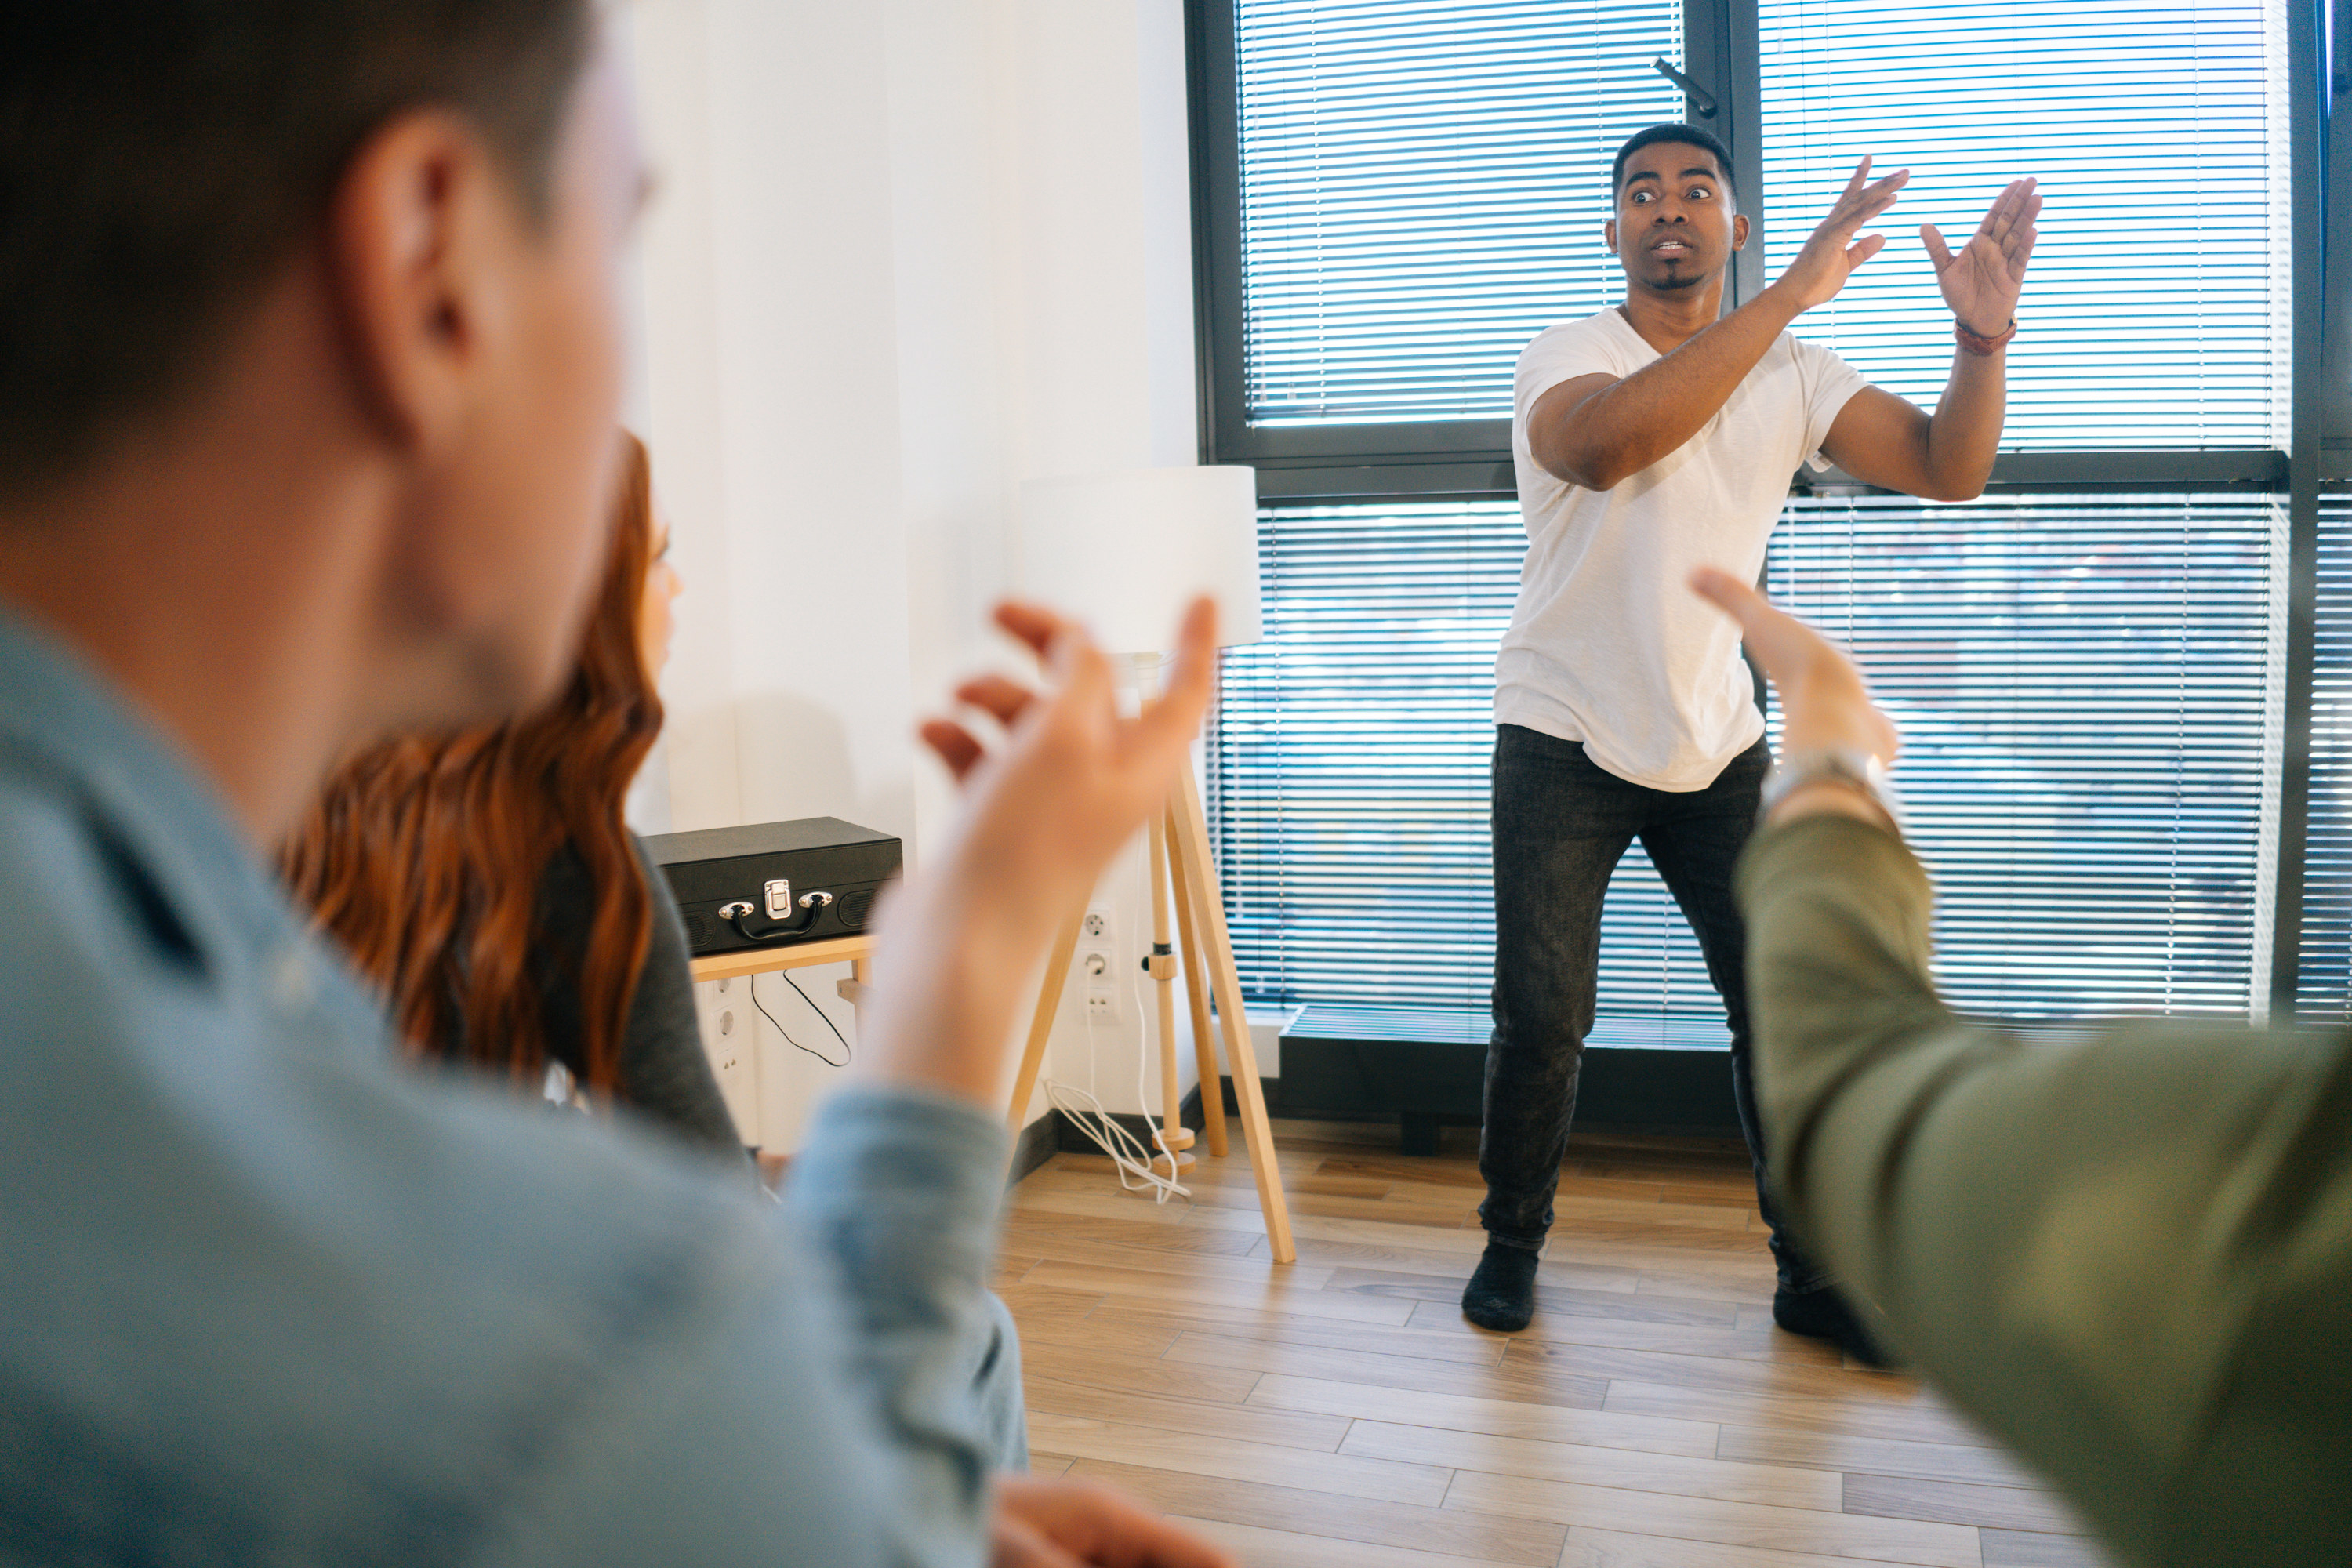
[1526,158,1910,489]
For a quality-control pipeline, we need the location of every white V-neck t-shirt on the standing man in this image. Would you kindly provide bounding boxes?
[1494,308,1865,789]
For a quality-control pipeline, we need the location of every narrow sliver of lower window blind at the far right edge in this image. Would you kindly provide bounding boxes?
[2296,492,2352,1025]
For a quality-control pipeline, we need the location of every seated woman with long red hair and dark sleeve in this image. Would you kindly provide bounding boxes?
[282,433,743,1161]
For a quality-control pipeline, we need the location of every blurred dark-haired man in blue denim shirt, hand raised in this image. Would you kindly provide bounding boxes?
[0,0,1223,1568]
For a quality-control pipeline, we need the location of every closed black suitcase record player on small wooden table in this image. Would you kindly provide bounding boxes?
[644,815,901,956]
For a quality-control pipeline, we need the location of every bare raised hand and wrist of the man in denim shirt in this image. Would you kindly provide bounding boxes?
[861,600,1216,1105]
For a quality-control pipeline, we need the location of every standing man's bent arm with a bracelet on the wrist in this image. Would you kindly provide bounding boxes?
[1820,179,2042,501]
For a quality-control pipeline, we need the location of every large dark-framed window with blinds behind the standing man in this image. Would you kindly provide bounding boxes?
[1195,0,2352,1041]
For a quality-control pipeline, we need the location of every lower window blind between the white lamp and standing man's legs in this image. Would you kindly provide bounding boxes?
[1209,501,1722,1039]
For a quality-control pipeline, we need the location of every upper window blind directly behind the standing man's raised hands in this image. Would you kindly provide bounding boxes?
[1757,0,2288,449]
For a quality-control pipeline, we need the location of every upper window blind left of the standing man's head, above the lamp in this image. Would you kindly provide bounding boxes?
[1235,0,1682,426]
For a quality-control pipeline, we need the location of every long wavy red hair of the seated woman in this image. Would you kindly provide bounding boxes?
[280,433,661,1093]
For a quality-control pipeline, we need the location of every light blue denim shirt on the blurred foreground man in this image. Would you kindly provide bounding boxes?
[0,616,1007,1568]
